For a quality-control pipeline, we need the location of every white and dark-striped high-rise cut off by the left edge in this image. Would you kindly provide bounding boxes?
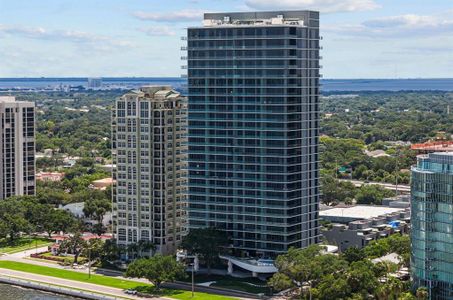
[0,96,36,200]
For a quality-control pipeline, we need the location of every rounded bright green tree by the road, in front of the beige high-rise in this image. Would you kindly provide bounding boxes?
[125,254,186,290]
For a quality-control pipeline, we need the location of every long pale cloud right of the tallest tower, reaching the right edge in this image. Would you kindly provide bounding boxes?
[323,11,453,38]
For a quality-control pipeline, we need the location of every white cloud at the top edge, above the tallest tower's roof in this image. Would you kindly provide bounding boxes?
[245,0,380,13]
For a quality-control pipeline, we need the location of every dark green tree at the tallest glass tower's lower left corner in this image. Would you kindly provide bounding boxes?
[181,228,229,274]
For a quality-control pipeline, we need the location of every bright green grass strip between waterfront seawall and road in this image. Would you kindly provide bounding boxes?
[0,261,235,300]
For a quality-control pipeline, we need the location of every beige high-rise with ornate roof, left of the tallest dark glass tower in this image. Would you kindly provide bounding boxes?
[113,86,187,254]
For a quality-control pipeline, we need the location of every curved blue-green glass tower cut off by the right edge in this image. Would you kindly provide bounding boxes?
[411,152,453,299]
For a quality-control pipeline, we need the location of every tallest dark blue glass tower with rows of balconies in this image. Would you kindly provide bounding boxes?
[187,11,320,256]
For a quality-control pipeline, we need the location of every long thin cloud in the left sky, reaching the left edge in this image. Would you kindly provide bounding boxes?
[0,24,133,48]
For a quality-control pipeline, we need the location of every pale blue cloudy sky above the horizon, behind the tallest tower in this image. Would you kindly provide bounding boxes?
[0,0,453,79]
